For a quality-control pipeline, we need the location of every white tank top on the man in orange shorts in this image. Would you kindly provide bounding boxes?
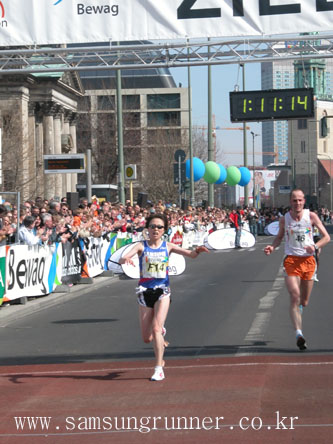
[284,210,314,256]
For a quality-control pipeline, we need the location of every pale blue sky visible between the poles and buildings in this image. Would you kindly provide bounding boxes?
[170,63,262,167]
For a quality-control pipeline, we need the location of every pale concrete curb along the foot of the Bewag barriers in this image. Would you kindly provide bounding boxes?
[0,274,119,327]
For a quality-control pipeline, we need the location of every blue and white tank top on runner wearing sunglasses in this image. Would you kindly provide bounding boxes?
[139,241,169,288]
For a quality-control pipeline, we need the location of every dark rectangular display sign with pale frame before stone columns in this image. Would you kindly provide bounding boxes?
[43,154,86,174]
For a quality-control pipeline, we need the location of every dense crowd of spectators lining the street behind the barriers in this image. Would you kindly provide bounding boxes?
[0,196,333,245]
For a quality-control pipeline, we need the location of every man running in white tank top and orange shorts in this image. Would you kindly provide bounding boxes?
[264,189,330,350]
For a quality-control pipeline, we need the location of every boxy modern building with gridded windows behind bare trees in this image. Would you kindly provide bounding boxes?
[77,84,189,203]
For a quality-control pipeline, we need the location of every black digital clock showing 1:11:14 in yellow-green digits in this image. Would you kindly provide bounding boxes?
[229,88,314,122]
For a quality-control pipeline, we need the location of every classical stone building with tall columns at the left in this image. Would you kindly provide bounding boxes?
[0,73,83,200]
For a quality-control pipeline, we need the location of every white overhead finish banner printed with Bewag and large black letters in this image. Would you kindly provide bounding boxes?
[0,0,333,46]
